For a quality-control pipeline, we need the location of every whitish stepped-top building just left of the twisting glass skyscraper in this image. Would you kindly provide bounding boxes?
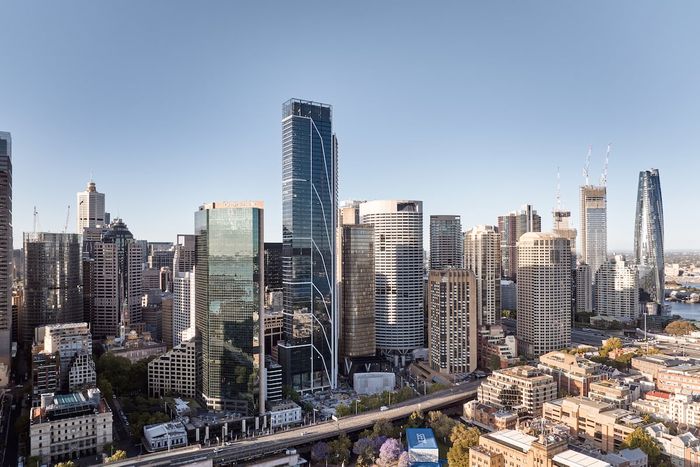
[595,255,639,322]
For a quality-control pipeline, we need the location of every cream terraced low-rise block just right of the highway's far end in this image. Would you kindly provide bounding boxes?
[478,365,557,416]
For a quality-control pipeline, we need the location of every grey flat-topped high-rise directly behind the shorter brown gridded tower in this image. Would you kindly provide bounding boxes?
[430,216,464,269]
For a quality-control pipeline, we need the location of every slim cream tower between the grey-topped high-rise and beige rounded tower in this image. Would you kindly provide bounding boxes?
[464,225,501,326]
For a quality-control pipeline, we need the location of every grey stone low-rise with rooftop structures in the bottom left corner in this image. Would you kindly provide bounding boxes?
[29,388,112,463]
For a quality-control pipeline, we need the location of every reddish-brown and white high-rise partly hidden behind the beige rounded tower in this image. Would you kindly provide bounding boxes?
[498,204,542,280]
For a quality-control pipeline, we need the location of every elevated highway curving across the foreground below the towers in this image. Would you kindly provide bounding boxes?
[104,381,481,467]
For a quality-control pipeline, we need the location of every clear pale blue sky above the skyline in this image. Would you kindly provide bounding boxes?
[0,0,700,251]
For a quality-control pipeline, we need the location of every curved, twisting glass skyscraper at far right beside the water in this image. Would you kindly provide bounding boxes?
[634,169,664,305]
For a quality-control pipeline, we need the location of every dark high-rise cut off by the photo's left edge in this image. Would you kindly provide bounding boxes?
[0,131,12,387]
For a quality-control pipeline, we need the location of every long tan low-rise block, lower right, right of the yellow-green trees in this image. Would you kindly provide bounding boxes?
[543,397,644,451]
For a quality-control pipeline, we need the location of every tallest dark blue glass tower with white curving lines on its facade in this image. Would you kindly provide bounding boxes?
[278,99,338,391]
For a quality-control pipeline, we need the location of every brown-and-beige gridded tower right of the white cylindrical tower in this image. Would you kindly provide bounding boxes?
[428,268,478,374]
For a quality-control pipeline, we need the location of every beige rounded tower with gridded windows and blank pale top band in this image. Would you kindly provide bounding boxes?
[517,232,571,356]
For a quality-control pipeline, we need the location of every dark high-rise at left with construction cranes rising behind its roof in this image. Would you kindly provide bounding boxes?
[21,232,83,345]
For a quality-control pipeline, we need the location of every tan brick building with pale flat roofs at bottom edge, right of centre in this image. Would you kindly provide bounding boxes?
[469,430,611,467]
